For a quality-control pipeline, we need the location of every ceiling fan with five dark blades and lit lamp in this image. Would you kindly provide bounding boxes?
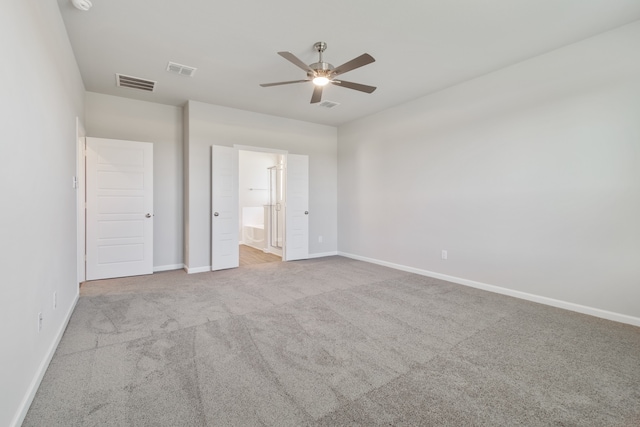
[260,42,376,104]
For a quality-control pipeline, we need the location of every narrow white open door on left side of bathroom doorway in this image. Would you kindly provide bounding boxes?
[211,145,240,271]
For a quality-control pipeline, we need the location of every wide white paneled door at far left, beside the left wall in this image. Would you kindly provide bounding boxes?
[86,138,153,280]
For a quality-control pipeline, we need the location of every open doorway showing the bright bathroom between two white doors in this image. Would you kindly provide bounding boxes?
[238,150,286,266]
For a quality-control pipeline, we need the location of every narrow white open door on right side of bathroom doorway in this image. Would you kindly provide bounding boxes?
[284,154,309,261]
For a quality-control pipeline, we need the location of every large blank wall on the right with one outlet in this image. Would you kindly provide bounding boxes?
[338,22,640,324]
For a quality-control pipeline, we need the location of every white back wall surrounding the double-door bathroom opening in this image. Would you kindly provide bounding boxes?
[185,101,337,271]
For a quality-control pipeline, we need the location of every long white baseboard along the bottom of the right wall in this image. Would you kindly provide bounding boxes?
[338,251,640,326]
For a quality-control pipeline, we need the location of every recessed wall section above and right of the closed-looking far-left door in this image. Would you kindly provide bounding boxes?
[86,89,184,271]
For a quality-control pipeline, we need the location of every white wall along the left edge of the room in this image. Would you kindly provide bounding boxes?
[0,0,84,426]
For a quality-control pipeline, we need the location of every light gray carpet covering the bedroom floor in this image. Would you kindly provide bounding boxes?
[24,257,640,427]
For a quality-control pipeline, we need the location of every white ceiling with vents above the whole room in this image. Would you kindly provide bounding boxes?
[58,0,640,126]
